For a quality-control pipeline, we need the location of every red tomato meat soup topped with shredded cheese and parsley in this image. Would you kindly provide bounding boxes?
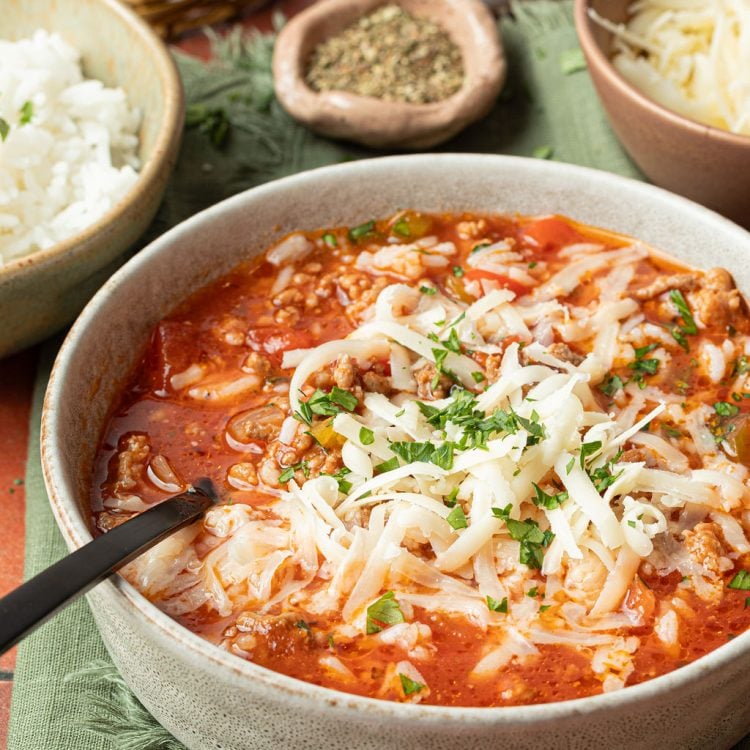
[92,211,750,706]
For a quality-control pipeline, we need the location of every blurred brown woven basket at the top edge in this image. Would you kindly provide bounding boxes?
[122,0,276,39]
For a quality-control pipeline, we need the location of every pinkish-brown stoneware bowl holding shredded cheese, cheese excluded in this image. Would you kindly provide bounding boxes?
[575,0,750,227]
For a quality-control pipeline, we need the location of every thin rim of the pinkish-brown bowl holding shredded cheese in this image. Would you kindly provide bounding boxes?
[573,0,750,149]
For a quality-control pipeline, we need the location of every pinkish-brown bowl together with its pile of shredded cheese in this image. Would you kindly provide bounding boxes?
[575,0,750,226]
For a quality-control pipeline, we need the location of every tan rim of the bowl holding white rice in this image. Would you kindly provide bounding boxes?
[0,0,184,283]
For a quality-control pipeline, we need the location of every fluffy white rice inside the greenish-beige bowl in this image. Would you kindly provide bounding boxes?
[0,30,141,265]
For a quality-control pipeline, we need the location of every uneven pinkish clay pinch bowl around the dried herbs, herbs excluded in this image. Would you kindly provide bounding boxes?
[273,0,506,149]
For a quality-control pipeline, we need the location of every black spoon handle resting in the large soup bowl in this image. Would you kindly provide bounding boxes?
[0,479,216,654]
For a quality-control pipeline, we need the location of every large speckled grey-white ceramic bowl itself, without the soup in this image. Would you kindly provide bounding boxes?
[42,154,750,750]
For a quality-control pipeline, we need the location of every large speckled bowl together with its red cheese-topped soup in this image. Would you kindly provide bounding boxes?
[42,155,750,749]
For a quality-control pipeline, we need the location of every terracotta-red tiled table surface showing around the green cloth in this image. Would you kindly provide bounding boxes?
[0,0,314,750]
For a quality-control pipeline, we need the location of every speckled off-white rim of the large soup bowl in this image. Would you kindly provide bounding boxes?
[41,154,750,727]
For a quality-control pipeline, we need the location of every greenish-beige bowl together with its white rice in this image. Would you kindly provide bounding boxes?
[0,0,183,356]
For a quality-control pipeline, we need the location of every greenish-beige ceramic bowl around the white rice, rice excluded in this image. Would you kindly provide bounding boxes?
[0,0,183,357]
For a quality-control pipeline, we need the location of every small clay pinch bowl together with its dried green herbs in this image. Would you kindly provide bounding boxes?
[273,0,506,149]
